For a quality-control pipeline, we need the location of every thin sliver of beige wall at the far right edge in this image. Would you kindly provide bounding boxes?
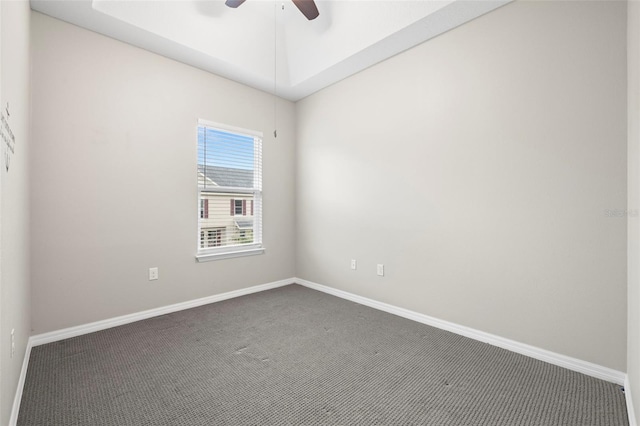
[627,1,640,422]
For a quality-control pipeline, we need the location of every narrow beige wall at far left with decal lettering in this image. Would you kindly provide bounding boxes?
[0,1,31,425]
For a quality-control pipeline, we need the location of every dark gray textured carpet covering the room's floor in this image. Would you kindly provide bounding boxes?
[18,285,628,426]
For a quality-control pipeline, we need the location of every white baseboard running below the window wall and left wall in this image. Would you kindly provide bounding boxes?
[9,278,295,426]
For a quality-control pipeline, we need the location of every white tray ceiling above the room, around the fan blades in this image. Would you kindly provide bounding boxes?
[31,0,512,101]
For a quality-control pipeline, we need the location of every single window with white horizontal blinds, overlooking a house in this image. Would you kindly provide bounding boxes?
[197,120,264,261]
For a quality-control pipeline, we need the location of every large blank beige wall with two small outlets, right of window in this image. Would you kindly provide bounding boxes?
[297,1,627,371]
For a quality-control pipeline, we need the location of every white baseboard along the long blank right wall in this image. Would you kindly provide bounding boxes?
[295,278,626,385]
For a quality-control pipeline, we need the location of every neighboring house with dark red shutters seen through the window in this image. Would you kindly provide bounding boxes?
[198,165,256,248]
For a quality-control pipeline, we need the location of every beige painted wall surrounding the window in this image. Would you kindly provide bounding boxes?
[31,12,295,334]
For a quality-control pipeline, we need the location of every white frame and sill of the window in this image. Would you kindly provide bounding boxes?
[196,119,265,262]
